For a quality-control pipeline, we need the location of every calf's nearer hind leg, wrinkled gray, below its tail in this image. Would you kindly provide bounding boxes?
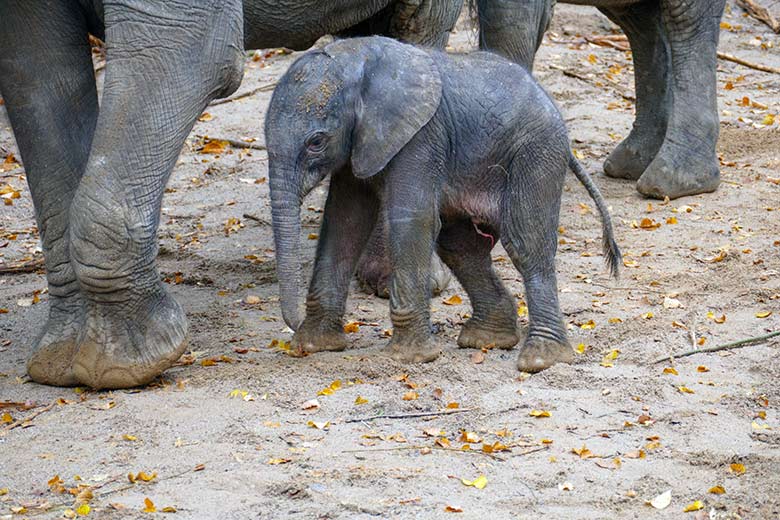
[501,152,574,372]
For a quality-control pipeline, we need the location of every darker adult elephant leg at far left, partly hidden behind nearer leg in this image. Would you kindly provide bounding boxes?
[0,0,98,386]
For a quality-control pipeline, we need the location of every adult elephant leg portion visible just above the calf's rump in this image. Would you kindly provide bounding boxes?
[471,0,553,71]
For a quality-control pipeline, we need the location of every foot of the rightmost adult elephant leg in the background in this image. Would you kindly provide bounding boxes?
[636,142,720,199]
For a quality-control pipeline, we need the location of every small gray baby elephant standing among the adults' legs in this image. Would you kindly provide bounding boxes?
[265,37,620,372]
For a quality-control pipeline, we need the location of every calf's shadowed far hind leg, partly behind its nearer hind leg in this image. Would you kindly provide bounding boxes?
[438,219,520,348]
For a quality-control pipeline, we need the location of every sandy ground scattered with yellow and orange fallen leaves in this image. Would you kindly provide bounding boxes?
[0,2,780,519]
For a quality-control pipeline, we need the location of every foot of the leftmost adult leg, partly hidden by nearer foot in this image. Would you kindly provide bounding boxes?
[27,297,84,386]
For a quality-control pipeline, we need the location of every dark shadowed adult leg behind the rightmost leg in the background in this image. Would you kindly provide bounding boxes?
[602,2,671,180]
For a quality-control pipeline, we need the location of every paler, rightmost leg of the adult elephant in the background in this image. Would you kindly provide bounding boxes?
[637,0,725,199]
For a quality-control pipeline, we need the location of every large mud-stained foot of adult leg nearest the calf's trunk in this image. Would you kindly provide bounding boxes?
[73,287,187,389]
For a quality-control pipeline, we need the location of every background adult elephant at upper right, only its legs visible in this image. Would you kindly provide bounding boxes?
[472,0,726,199]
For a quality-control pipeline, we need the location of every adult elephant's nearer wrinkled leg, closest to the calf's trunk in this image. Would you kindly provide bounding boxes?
[70,0,243,388]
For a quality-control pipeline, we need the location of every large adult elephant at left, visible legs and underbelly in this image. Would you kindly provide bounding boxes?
[0,0,462,388]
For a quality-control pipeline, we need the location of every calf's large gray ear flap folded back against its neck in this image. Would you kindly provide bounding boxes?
[327,37,441,178]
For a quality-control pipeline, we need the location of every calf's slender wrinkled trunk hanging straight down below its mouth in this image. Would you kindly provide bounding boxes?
[271,190,301,330]
